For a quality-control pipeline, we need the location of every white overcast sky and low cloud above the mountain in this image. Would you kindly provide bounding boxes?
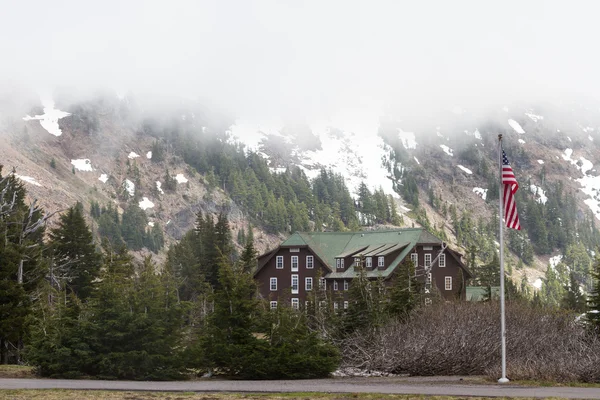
[0,0,600,118]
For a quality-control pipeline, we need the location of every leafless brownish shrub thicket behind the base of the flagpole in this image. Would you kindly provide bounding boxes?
[341,302,600,382]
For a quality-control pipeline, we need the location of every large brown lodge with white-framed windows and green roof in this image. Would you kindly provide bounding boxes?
[254,228,472,309]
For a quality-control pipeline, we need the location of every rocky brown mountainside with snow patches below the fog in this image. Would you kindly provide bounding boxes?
[0,96,600,287]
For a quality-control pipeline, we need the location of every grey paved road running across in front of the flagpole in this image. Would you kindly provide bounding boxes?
[0,378,600,399]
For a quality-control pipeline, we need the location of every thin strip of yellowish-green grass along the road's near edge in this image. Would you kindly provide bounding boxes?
[0,389,552,400]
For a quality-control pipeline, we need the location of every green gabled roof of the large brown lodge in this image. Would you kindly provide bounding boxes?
[281,228,441,278]
